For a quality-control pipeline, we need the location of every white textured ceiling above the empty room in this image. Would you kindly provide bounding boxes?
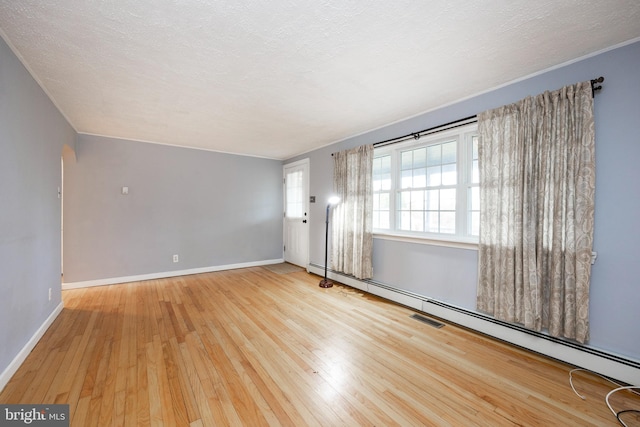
[0,0,640,159]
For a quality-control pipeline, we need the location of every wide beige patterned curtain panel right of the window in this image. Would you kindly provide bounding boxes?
[477,81,595,343]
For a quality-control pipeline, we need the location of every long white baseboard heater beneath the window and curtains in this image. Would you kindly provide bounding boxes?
[308,264,640,385]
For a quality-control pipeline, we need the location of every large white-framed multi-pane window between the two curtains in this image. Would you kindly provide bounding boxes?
[373,123,480,242]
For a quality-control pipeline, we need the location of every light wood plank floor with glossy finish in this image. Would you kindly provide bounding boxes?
[0,267,640,426]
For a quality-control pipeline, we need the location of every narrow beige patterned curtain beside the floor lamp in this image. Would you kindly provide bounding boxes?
[331,145,373,279]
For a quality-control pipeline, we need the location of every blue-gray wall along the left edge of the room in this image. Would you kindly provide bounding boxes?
[0,39,75,373]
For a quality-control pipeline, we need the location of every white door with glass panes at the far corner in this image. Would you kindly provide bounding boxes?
[283,159,309,268]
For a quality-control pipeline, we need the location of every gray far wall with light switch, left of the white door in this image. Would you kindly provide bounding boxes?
[64,134,282,283]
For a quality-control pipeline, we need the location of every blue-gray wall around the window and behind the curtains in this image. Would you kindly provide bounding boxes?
[285,42,640,361]
